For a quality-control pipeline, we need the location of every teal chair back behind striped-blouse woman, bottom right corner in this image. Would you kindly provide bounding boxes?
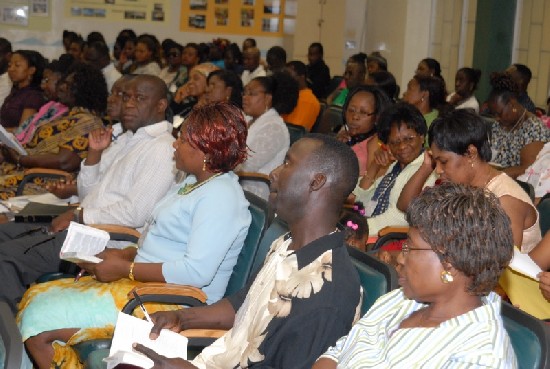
[501,302,550,369]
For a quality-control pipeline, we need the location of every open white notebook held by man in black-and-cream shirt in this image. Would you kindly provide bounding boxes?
[103,312,187,369]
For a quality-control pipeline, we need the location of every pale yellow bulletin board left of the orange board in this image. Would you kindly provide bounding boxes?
[65,0,170,23]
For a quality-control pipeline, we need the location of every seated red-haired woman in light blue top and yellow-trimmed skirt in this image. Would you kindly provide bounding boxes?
[17,103,251,369]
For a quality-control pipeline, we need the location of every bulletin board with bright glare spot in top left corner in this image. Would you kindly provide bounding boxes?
[0,0,52,31]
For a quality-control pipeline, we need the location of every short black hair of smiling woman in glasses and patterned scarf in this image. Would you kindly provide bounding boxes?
[377,102,428,144]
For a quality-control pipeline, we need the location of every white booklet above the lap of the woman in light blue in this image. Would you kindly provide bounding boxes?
[59,222,110,263]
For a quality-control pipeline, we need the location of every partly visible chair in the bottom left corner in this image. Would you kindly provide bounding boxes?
[0,301,23,369]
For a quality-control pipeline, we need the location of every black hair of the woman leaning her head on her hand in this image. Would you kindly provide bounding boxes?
[428,109,492,162]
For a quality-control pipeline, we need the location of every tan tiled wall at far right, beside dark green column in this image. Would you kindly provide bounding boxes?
[514,0,550,107]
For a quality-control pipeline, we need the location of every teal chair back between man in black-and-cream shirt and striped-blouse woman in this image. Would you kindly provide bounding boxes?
[348,246,398,315]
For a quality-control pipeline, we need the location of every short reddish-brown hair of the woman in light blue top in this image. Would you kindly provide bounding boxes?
[185,102,248,173]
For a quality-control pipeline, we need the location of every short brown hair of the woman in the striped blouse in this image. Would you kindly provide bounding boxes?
[407,183,514,295]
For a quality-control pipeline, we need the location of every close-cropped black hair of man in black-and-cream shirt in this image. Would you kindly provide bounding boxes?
[304,133,359,204]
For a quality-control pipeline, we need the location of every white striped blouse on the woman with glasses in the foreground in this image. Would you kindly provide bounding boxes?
[321,289,517,368]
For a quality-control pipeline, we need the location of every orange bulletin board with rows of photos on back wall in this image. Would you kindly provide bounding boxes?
[180,0,294,36]
